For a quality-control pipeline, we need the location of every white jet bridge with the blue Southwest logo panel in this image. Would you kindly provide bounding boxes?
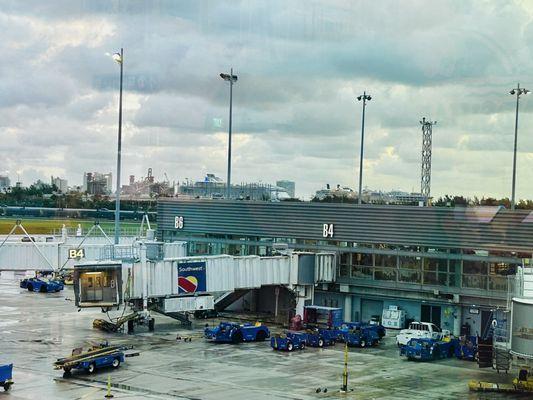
[74,243,335,324]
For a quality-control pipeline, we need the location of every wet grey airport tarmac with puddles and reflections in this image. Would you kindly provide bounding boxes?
[0,280,526,400]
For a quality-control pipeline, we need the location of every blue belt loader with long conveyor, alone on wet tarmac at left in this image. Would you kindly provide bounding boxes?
[54,343,126,376]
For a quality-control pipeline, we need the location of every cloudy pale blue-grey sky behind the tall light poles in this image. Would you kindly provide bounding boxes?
[0,0,533,199]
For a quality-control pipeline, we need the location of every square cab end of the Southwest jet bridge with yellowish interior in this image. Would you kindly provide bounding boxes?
[73,261,122,308]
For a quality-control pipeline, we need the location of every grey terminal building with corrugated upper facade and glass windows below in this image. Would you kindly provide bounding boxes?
[157,200,533,335]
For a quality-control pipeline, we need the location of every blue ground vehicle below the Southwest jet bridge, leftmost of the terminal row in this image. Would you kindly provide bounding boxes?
[204,322,270,343]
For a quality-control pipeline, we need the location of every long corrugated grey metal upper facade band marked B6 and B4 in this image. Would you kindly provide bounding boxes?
[157,200,533,252]
